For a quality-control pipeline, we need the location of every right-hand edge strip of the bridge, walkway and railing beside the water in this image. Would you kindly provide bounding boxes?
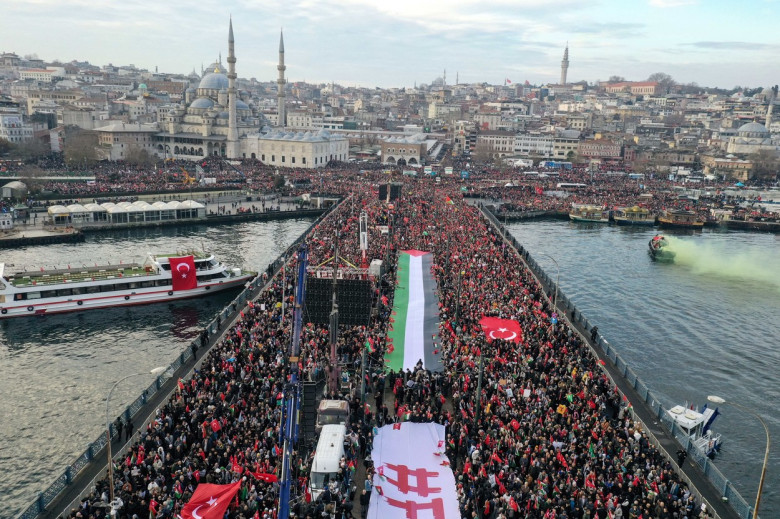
[480,206,753,519]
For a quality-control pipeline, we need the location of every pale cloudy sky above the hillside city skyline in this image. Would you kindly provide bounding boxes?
[0,0,780,88]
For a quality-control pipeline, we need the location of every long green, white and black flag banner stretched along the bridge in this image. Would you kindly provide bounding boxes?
[385,250,444,371]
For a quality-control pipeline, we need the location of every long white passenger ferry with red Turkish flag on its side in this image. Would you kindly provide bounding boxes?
[0,251,257,319]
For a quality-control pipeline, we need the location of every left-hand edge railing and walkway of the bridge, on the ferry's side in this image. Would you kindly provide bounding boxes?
[17,204,338,519]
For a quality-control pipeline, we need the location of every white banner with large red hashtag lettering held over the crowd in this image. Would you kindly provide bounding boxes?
[368,422,460,519]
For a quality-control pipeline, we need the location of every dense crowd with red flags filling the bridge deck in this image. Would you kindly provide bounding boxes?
[61,170,724,519]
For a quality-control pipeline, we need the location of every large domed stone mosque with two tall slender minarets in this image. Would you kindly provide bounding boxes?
[152,19,349,168]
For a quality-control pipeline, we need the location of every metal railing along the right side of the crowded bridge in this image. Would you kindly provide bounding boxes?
[482,208,753,519]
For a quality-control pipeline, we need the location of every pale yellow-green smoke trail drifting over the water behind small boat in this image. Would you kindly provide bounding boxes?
[666,236,780,290]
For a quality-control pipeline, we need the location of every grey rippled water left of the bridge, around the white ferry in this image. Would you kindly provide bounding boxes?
[0,219,311,518]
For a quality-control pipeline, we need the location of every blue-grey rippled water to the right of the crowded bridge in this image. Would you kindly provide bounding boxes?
[508,221,780,518]
